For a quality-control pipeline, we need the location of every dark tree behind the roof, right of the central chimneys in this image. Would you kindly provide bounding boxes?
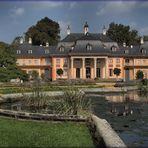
[107,22,140,46]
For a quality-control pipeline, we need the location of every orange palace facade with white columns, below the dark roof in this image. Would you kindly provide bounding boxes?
[17,56,148,80]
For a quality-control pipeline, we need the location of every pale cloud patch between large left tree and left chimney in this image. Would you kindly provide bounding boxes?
[58,21,71,38]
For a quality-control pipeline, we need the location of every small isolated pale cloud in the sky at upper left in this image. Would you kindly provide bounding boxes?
[10,7,25,17]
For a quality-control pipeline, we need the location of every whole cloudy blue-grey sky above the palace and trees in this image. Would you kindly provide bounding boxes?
[0,1,148,43]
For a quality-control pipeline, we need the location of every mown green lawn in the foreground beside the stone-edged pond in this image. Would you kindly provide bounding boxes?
[0,117,94,148]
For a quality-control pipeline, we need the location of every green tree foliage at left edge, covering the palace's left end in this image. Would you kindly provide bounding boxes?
[0,42,28,82]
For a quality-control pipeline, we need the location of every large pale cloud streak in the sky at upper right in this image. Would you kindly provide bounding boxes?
[96,1,137,16]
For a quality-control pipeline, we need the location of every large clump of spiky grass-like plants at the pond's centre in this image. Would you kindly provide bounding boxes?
[57,87,91,115]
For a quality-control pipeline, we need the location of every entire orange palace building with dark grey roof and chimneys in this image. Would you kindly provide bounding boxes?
[16,22,148,80]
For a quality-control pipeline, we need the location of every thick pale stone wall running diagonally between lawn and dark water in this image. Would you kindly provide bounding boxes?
[90,115,127,148]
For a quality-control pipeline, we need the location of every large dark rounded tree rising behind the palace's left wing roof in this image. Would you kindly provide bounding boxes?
[25,17,60,45]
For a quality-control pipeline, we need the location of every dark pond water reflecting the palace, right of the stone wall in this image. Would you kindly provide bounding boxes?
[87,92,148,147]
